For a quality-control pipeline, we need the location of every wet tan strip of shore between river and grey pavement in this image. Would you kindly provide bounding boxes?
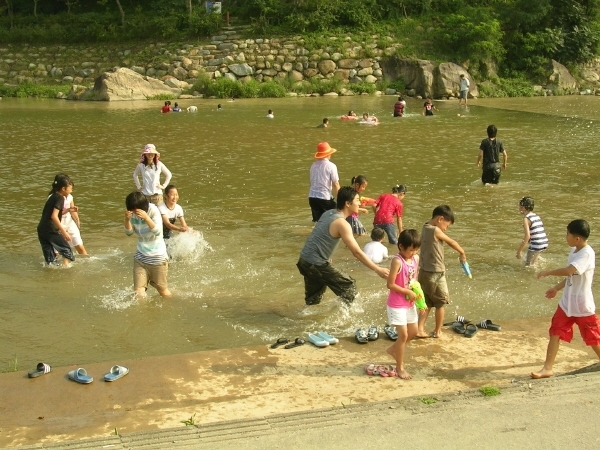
[0,318,597,447]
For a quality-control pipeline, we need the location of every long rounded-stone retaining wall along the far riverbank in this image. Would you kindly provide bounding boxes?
[0,29,401,89]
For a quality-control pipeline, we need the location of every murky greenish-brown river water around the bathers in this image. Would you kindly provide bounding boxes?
[0,96,600,371]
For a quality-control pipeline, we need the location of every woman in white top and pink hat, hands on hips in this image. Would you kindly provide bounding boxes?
[133,144,171,206]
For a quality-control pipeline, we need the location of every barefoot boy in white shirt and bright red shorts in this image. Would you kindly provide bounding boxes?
[531,219,600,379]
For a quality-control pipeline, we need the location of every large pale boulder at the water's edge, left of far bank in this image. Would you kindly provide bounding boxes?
[74,67,181,102]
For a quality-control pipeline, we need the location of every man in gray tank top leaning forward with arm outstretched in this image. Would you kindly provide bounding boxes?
[296,186,389,305]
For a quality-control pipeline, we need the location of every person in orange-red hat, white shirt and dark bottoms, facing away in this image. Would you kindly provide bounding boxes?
[308,142,340,222]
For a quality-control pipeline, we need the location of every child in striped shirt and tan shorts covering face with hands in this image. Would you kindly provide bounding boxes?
[125,191,171,297]
